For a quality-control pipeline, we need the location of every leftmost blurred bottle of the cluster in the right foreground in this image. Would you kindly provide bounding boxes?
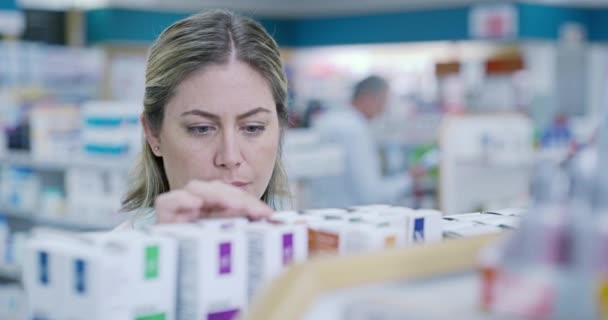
[492,163,569,319]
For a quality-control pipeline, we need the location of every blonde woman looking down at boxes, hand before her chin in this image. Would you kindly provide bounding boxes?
[119,11,288,229]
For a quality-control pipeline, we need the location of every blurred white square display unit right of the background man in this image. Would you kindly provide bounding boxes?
[438,113,534,214]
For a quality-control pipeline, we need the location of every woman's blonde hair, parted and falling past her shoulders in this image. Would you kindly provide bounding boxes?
[122,10,289,211]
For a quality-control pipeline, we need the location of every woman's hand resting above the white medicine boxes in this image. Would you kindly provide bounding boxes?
[154,181,272,223]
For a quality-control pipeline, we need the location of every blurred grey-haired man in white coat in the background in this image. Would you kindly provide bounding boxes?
[310,75,411,207]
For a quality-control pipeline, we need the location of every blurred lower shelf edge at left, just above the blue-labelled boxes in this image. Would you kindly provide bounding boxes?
[0,207,116,231]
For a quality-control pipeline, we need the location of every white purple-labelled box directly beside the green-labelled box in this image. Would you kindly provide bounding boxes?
[150,219,247,320]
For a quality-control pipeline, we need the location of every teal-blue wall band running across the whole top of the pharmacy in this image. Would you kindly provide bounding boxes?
[84,0,608,47]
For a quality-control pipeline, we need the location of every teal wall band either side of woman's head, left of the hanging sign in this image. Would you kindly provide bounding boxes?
[86,7,469,46]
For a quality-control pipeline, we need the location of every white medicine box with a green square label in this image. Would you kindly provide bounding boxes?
[71,232,177,319]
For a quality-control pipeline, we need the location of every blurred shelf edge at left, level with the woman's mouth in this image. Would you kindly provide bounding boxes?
[0,152,134,172]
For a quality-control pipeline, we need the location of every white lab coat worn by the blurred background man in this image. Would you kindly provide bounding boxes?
[310,107,411,208]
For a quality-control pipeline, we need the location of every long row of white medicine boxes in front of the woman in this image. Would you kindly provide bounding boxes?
[24,206,508,320]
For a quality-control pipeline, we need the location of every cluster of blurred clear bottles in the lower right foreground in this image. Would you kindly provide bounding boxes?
[480,112,608,319]
